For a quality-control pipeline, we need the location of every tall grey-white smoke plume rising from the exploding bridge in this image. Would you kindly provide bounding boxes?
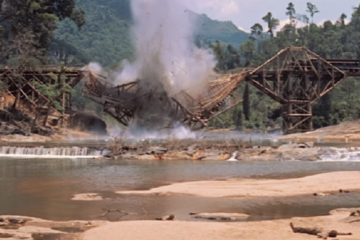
[88,0,216,138]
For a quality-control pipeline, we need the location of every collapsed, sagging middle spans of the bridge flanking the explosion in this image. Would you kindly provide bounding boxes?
[84,70,248,130]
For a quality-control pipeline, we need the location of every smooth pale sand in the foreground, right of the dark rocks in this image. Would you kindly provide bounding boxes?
[83,212,360,240]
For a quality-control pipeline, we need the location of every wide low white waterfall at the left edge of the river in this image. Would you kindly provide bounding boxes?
[0,146,110,158]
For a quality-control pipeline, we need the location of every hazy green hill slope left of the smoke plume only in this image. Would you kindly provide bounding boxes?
[55,0,133,67]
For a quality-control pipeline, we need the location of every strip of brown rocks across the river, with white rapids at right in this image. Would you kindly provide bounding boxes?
[108,142,360,161]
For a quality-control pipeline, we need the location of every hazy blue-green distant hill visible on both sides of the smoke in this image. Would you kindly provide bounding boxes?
[55,0,249,67]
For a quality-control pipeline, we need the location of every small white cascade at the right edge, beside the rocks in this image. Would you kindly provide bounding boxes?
[319,147,360,162]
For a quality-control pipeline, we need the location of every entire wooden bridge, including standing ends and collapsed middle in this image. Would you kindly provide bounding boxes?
[0,47,360,134]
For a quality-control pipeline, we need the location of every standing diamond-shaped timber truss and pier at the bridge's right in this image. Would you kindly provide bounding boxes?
[246,47,360,134]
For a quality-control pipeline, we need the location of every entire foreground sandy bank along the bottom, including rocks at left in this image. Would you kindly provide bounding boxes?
[0,212,360,240]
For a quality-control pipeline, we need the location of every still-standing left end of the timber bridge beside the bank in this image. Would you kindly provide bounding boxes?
[0,66,84,121]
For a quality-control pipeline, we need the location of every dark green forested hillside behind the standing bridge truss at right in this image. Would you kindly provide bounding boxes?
[211,3,360,129]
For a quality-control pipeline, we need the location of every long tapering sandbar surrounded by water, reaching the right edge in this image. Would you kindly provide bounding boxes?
[117,171,360,197]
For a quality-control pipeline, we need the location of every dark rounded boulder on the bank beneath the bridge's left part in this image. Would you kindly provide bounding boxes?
[68,112,107,135]
